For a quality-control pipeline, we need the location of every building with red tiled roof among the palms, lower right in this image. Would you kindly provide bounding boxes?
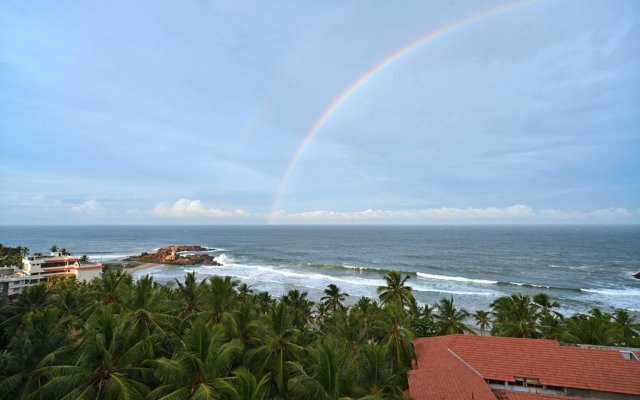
[408,335,640,400]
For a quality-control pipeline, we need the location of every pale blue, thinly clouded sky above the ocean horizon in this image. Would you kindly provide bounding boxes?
[0,0,640,224]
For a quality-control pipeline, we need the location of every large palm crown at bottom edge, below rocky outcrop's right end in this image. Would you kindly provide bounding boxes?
[148,320,243,400]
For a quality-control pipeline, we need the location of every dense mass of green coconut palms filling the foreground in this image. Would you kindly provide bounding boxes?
[0,271,639,400]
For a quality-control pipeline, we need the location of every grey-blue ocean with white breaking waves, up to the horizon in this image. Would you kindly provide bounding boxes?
[0,225,640,314]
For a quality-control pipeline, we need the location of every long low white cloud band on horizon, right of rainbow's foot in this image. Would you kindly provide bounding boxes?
[274,204,534,221]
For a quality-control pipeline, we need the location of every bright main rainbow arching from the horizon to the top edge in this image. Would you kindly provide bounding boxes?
[267,0,540,224]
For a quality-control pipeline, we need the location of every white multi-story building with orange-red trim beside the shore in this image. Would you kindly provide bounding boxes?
[0,252,103,297]
